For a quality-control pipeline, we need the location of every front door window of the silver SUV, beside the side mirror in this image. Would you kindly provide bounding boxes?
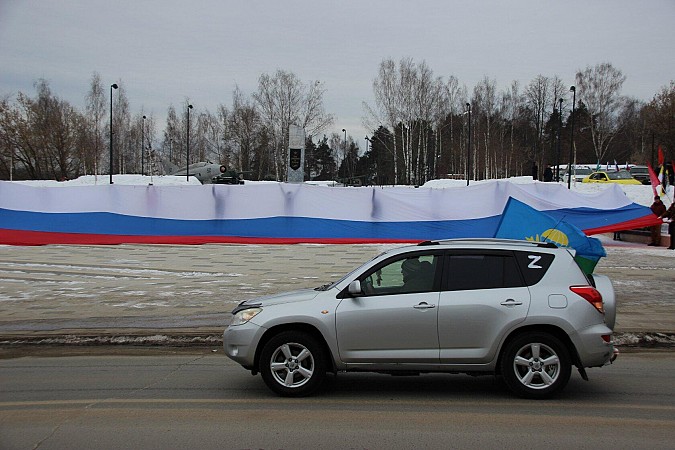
[361,255,439,296]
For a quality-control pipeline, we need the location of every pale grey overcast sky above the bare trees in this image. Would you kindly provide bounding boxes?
[0,0,675,146]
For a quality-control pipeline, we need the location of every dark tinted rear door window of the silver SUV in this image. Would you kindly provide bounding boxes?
[445,253,525,291]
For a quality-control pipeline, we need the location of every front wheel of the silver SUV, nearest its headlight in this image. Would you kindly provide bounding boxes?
[260,331,326,397]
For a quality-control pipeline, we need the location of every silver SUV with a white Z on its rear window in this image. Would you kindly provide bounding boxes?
[223,239,617,398]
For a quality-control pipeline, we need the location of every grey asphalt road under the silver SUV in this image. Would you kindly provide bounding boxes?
[0,347,675,450]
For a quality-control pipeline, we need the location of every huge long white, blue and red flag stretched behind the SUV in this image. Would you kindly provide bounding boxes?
[0,181,656,245]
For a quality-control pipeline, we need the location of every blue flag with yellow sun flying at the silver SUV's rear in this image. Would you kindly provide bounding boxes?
[495,197,607,274]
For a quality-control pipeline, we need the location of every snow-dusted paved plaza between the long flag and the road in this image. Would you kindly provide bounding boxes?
[0,241,675,344]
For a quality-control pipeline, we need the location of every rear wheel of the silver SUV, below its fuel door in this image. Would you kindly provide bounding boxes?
[501,333,572,399]
